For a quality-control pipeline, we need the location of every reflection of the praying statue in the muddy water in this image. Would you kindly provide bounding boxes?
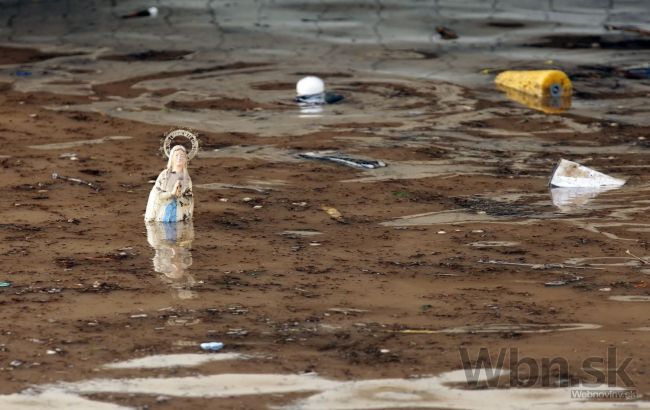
[146,220,197,299]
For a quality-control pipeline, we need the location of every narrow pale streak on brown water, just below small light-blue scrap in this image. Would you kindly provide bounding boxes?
[104,353,246,369]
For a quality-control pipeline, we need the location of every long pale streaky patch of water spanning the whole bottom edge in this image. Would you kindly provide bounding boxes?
[6,369,650,410]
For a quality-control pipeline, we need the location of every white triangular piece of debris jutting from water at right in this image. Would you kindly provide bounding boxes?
[549,159,625,188]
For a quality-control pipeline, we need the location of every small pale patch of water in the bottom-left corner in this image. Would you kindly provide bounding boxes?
[0,390,131,410]
